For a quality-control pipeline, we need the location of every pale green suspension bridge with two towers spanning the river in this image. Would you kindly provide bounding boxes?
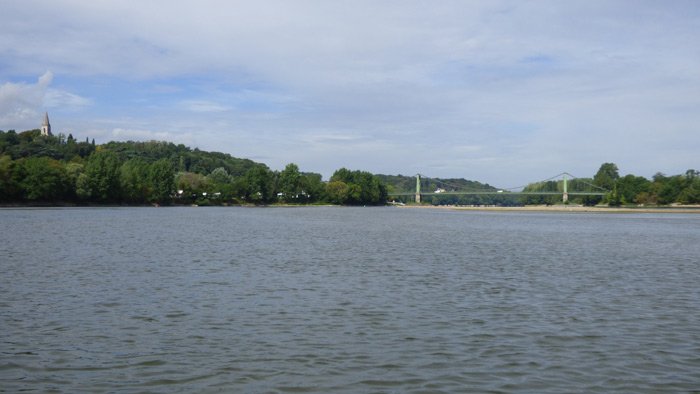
[389,172,610,203]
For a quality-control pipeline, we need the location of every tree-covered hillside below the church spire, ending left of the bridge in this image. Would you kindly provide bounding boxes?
[0,130,387,205]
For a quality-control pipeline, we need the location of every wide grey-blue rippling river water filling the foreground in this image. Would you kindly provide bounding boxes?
[0,207,700,393]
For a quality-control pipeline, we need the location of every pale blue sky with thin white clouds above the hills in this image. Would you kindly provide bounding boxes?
[0,0,700,188]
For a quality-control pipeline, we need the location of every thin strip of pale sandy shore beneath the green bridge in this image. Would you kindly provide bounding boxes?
[402,205,700,214]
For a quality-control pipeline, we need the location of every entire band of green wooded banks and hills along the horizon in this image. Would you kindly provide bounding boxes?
[0,129,700,206]
